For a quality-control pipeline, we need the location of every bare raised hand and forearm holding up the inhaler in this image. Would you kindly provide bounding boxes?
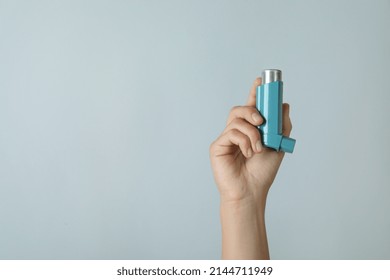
[210,78,292,259]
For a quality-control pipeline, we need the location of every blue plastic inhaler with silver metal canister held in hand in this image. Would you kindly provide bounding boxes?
[256,69,295,153]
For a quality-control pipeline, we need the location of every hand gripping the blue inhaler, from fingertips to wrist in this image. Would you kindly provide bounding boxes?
[210,78,292,205]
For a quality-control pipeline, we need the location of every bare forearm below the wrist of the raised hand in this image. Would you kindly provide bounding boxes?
[221,198,269,260]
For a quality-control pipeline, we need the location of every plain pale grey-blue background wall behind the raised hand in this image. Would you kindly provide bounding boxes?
[0,0,390,259]
